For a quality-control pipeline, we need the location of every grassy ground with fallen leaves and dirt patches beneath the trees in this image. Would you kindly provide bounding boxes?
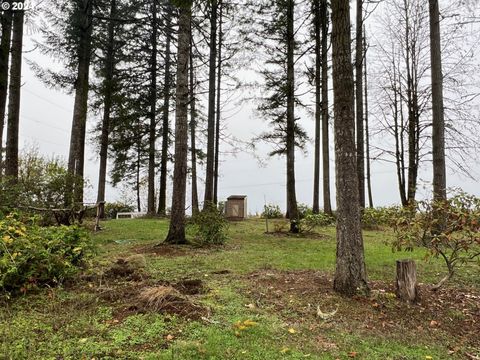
[0,219,480,360]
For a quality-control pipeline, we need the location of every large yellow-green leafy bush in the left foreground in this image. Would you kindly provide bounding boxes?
[0,214,93,294]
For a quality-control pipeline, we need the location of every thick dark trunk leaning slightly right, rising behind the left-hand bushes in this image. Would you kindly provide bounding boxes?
[65,0,93,207]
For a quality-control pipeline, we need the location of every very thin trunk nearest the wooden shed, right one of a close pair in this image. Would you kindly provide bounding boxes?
[213,0,223,204]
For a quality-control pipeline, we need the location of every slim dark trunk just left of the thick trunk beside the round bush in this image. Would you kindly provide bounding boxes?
[158,3,172,216]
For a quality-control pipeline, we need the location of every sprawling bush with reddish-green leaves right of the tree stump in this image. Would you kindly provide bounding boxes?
[393,193,480,289]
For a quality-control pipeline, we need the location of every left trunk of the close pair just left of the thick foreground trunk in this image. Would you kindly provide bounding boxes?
[313,1,325,214]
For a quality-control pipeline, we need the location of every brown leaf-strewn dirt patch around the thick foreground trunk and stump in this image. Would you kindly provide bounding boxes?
[247,269,480,354]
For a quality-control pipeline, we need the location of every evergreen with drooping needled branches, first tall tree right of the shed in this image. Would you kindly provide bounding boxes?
[258,0,307,224]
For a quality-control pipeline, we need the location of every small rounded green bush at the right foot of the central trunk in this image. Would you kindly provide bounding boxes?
[188,206,228,246]
